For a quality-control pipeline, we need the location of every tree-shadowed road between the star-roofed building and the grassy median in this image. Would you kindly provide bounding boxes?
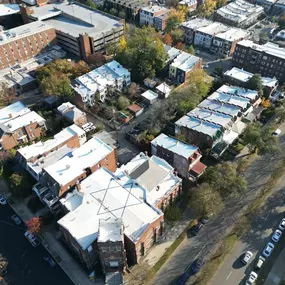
[152,124,285,285]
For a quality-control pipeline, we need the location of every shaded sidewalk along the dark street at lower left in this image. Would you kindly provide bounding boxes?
[0,180,94,285]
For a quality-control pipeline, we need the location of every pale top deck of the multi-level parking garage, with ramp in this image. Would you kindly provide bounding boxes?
[29,1,124,39]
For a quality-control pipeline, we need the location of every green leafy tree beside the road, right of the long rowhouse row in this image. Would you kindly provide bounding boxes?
[243,123,280,155]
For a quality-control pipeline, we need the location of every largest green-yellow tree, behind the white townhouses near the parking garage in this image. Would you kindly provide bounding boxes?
[116,27,167,81]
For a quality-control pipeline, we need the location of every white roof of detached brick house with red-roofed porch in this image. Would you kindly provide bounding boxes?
[151,134,198,159]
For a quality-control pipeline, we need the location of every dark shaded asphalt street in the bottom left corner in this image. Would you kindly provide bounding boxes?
[0,205,73,285]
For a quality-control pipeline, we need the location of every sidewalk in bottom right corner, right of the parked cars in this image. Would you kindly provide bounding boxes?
[264,248,285,285]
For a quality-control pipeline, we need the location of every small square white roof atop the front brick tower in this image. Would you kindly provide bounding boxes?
[98,218,124,242]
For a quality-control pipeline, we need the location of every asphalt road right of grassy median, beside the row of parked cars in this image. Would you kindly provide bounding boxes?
[210,175,285,285]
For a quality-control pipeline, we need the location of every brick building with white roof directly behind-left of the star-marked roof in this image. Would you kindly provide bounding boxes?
[33,137,117,212]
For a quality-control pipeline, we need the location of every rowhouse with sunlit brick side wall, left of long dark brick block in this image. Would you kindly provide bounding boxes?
[210,28,250,57]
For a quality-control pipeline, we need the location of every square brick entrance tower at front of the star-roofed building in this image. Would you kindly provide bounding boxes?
[97,218,127,284]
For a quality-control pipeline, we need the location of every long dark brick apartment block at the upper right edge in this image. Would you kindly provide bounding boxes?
[232,40,285,83]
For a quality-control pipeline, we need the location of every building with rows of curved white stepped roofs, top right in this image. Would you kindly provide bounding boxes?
[214,0,264,28]
